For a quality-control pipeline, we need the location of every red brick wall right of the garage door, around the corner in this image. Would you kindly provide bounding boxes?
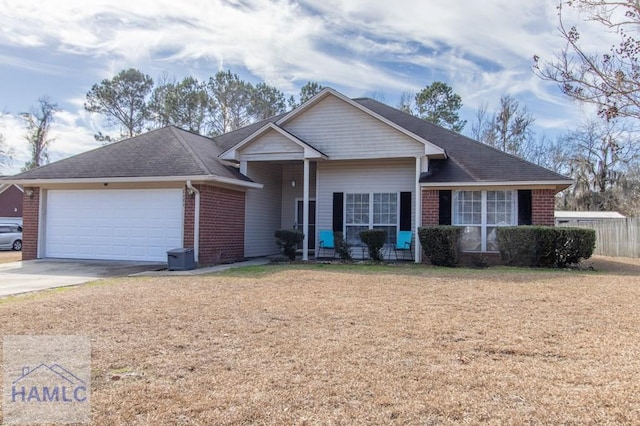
[184,185,245,265]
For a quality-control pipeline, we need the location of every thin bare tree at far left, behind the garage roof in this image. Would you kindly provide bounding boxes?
[22,97,60,171]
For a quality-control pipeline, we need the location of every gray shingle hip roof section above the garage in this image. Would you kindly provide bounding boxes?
[11,126,250,181]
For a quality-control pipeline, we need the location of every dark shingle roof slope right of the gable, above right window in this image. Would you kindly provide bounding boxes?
[354,98,571,183]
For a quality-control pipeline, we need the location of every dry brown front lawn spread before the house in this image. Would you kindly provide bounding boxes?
[0,258,640,425]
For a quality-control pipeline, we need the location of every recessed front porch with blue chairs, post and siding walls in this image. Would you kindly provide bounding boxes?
[245,159,420,261]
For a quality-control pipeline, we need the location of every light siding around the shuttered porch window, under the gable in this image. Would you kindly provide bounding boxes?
[317,159,416,246]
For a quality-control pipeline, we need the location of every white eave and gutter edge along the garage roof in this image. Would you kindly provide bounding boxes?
[4,175,264,189]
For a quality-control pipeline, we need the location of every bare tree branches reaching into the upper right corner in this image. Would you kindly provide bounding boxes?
[533,0,640,119]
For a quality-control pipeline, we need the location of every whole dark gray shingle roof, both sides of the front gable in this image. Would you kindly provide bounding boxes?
[5,98,570,183]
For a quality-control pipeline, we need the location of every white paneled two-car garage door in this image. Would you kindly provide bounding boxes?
[45,189,183,262]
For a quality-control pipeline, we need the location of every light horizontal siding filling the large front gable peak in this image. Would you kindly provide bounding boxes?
[283,96,425,160]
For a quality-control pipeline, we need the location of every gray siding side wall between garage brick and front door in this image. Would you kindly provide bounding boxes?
[244,162,282,257]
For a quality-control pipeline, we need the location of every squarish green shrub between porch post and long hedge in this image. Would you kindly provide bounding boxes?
[418,226,462,266]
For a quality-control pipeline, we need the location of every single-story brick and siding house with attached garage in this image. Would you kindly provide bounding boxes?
[2,89,572,264]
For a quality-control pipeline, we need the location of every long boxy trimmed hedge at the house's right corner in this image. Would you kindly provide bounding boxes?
[498,226,596,268]
